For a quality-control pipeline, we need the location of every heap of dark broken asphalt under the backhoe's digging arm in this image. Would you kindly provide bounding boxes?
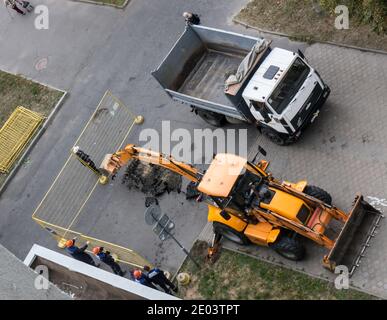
[122,159,182,197]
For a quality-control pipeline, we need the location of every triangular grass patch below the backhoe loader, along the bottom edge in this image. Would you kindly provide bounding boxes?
[180,242,376,300]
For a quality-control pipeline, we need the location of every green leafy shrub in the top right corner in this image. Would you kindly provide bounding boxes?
[320,0,387,34]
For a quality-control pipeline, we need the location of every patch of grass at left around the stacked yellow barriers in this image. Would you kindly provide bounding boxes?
[0,71,63,186]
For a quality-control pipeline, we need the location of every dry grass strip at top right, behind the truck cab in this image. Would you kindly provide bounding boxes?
[235,0,387,51]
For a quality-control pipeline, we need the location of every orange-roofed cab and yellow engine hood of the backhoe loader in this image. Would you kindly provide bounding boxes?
[197,153,314,222]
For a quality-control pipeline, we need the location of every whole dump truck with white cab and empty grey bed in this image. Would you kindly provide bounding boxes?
[152,25,330,145]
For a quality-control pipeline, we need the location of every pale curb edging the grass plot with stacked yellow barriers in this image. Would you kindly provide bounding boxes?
[0,88,68,198]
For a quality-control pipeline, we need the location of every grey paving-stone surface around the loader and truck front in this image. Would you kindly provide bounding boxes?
[200,44,387,298]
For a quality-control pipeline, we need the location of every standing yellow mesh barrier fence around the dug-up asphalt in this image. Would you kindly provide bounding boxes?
[32,91,152,268]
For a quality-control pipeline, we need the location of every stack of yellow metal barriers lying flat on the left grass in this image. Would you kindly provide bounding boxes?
[0,107,45,173]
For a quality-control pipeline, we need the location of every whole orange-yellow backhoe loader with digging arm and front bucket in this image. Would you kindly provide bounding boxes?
[101,144,383,274]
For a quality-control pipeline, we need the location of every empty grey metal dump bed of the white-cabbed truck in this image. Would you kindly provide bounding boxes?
[152,25,259,119]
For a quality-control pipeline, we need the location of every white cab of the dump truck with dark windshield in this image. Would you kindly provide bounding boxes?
[242,48,329,144]
